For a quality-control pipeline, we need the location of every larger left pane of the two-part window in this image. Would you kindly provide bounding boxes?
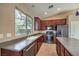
[15,9,26,35]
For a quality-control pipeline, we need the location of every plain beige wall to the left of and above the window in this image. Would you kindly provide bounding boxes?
[0,3,32,42]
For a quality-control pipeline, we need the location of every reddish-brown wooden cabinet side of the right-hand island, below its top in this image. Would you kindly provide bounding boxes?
[56,39,72,56]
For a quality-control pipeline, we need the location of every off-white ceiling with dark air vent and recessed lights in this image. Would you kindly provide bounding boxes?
[26,3,79,18]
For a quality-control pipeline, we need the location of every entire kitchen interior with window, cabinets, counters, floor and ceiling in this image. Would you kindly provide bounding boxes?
[0,3,79,56]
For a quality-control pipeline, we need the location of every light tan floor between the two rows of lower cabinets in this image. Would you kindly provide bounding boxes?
[36,43,57,56]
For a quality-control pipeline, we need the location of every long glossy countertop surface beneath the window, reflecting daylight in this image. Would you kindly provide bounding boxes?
[1,34,42,51]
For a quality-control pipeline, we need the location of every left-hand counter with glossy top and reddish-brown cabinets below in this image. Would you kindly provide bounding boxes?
[1,34,43,56]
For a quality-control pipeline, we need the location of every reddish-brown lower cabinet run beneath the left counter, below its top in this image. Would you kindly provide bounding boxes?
[1,36,43,56]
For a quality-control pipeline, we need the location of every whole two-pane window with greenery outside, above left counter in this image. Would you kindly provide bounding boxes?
[15,9,32,35]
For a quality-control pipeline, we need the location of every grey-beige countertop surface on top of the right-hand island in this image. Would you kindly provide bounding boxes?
[57,37,79,56]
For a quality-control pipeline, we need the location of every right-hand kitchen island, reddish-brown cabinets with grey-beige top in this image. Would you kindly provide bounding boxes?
[56,37,79,56]
